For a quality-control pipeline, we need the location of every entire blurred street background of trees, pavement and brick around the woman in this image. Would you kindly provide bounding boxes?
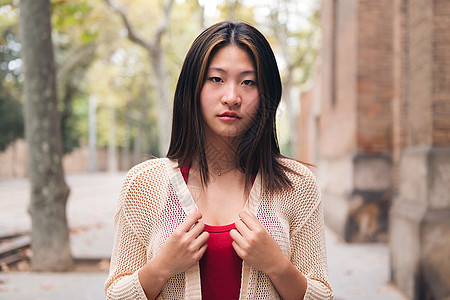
[0,0,450,299]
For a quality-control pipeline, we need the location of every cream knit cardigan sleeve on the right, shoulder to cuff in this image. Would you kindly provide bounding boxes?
[286,160,333,300]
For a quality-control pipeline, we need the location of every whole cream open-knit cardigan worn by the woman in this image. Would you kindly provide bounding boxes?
[105,158,332,300]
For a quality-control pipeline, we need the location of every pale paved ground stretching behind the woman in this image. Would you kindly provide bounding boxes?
[0,173,407,300]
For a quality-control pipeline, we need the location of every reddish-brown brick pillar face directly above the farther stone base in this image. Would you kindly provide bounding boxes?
[356,0,393,154]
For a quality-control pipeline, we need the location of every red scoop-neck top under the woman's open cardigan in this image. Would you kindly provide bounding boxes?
[181,165,242,300]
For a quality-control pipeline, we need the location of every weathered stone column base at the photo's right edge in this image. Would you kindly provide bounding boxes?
[389,147,450,300]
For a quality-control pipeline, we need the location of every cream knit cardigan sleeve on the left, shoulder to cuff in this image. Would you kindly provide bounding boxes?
[105,159,168,300]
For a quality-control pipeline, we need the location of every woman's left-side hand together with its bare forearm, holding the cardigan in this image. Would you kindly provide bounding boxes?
[139,212,209,299]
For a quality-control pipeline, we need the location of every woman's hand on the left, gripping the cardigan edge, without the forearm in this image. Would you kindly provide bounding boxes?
[154,212,209,277]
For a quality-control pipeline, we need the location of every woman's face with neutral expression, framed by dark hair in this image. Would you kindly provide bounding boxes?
[200,45,259,138]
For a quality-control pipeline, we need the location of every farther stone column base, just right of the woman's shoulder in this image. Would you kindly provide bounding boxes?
[318,155,392,242]
